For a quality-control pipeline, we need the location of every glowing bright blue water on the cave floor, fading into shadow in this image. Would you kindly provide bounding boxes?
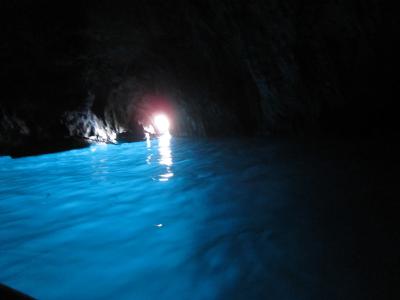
[0,138,346,299]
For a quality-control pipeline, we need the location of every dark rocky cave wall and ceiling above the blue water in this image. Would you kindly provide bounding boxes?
[0,0,399,152]
